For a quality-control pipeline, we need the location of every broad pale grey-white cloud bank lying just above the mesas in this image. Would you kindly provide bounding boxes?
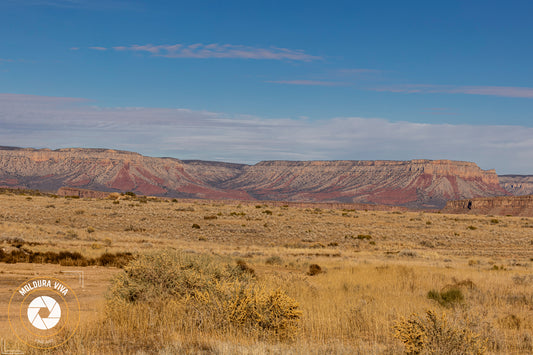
[0,94,533,174]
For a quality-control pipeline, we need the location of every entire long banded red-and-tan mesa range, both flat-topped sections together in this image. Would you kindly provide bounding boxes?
[0,147,510,209]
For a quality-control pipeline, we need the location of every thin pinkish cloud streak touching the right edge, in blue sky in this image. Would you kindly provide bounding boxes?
[372,84,533,98]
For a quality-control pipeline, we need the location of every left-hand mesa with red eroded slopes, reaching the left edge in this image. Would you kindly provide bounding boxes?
[0,148,250,199]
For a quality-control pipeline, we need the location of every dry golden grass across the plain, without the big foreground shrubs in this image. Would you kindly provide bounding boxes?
[0,194,533,354]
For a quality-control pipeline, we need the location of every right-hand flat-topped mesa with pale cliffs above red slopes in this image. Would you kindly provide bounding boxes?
[223,160,506,208]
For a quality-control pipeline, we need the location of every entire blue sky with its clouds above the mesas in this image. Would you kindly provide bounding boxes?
[0,0,533,174]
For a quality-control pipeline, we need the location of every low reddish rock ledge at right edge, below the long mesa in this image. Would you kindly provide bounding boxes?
[442,195,533,217]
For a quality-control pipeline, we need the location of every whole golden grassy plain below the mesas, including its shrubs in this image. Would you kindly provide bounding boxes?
[0,193,533,354]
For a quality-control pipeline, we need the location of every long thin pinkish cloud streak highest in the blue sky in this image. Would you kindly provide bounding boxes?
[90,43,322,62]
